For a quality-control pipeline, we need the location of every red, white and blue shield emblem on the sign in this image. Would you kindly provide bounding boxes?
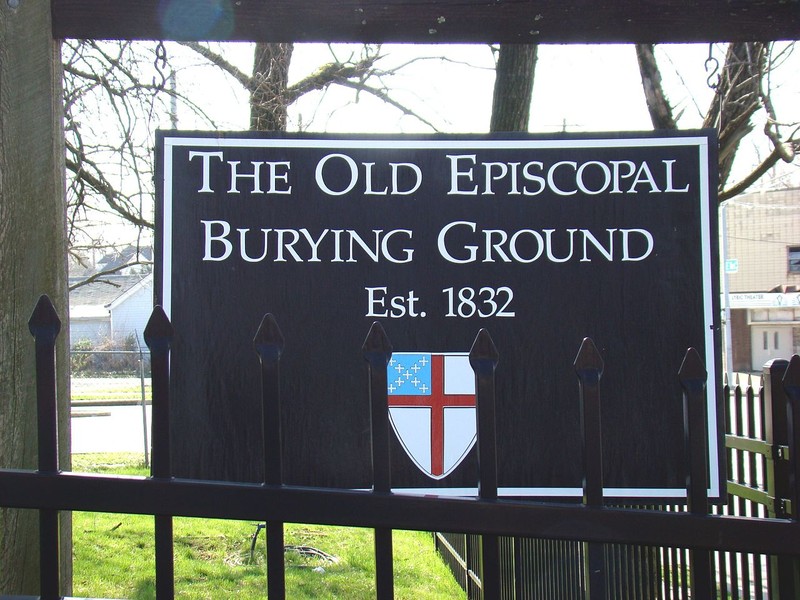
[387,352,477,479]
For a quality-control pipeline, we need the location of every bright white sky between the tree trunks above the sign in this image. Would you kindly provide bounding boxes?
[83,43,800,248]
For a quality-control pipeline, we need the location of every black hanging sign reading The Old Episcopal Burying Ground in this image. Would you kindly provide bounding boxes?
[156,131,722,498]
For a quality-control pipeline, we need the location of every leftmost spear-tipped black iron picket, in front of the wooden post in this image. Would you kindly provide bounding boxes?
[28,296,61,600]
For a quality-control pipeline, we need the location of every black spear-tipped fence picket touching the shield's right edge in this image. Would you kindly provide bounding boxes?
[469,329,500,600]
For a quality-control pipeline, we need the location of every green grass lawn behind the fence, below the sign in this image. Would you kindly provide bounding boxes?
[73,454,465,600]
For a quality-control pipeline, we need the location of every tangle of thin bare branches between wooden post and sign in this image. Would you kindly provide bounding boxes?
[63,40,172,280]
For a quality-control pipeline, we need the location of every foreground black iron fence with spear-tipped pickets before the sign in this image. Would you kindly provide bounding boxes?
[0,297,800,600]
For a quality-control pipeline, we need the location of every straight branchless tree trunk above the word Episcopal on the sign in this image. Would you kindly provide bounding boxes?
[489,44,539,132]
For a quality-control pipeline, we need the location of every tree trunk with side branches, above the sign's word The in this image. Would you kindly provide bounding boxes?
[250,43,294,131]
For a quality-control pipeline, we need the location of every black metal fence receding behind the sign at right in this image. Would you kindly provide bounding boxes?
[435,358,800,600]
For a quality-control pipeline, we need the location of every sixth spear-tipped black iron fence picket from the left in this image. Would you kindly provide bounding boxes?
[574,338,608,600]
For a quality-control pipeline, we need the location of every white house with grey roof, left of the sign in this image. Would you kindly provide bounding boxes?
[69,274,153,345]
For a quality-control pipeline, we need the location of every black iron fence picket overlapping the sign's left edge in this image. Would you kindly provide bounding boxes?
[144,306,175,600]
